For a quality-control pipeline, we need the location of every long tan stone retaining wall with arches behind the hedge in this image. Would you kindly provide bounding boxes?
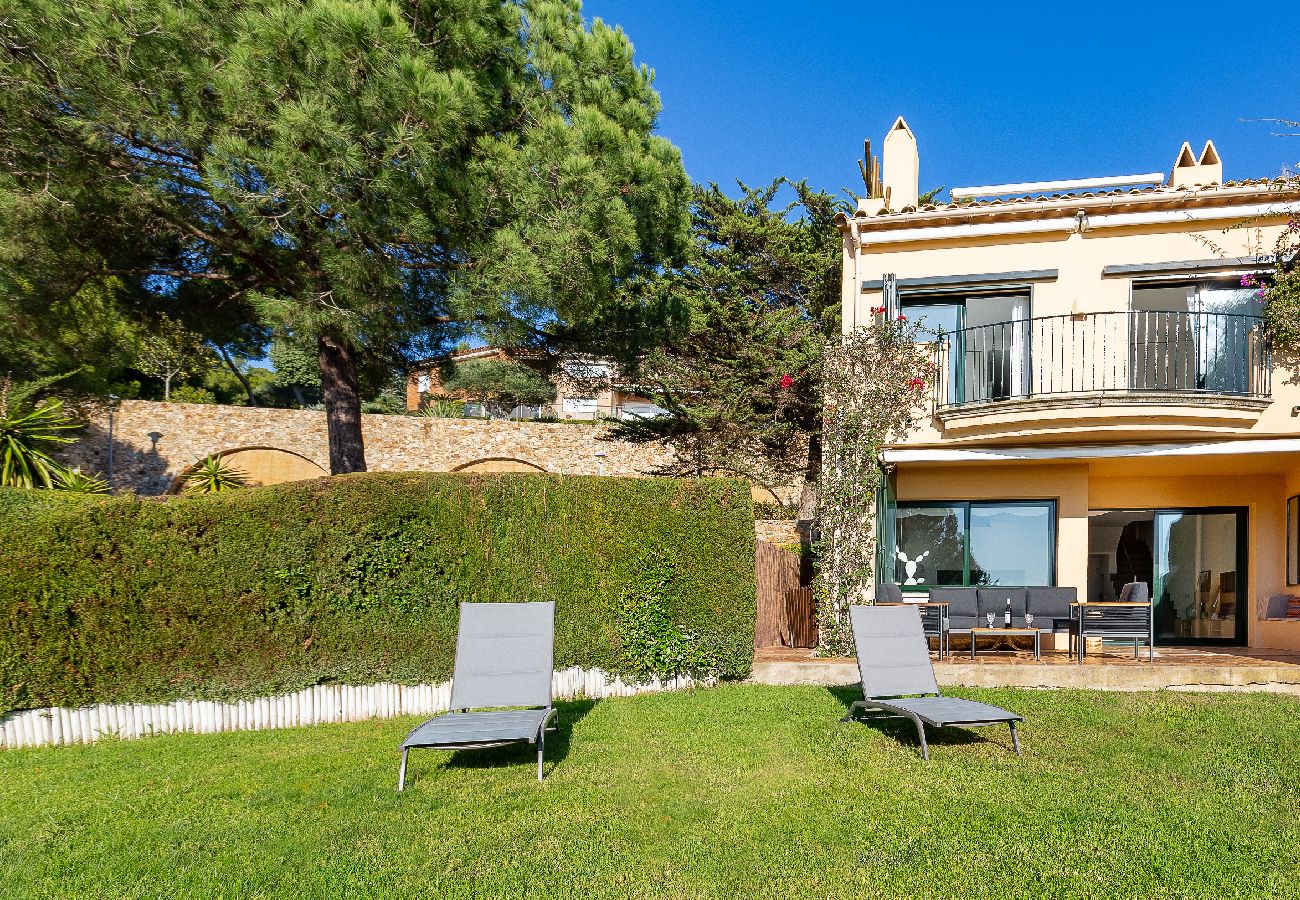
[62,401,671,494]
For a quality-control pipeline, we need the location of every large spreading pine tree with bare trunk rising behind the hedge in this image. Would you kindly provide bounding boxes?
[0,0,689,472]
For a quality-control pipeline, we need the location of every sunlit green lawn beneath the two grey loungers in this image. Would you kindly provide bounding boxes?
[0,685,1300,900]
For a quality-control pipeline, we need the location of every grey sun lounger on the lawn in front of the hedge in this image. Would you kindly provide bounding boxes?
[398,602,555,791]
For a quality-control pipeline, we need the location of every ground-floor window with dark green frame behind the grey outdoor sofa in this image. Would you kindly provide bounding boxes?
[894,501,1056,590]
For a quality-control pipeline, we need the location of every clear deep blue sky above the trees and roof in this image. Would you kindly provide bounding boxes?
[584,0,1300,200]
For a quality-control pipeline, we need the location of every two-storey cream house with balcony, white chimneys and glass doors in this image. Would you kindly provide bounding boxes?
[840,118,1300,649]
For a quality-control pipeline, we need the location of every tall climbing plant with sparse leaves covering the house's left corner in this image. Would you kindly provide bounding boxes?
[816,313,935,655]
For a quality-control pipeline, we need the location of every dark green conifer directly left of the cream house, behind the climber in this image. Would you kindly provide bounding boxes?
[619,178,844,515]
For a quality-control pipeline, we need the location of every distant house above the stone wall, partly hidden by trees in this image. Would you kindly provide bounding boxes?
[407,347,666,420]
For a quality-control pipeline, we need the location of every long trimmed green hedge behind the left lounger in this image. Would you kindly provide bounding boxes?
[0,473,754,713]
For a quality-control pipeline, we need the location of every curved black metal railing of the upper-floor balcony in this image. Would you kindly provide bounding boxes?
[935,312,1273,410]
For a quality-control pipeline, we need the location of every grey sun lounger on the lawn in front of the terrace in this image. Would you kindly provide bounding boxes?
[845,606,1024,760]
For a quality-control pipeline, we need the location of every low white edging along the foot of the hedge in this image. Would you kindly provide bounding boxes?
[0,666,711,750]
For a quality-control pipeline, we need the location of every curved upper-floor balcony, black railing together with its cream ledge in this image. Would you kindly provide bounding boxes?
[933,311,1273,428]
